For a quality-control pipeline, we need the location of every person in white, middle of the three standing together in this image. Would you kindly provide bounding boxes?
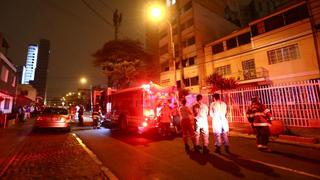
[192,94,209,153]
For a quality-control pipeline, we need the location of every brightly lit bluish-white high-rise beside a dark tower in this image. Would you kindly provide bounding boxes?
[21,44,38,84]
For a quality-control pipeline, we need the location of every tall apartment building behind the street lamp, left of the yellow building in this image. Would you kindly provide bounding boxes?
[159,0,239,92]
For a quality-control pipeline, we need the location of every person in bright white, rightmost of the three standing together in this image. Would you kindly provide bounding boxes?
[210,93,230,154]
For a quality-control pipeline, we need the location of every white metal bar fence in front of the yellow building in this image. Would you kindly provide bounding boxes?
[216,80,320,127]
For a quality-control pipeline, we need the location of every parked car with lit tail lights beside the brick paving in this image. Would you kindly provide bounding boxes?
[34,107,70,131]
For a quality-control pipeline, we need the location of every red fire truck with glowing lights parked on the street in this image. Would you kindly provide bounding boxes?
[107,83,176,133]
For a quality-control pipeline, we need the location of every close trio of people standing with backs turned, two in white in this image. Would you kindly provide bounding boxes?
[179,94,229,153]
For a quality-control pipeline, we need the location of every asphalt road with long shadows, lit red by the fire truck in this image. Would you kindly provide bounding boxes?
[73,128,320,179]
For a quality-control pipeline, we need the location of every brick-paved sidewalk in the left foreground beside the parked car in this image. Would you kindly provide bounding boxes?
[0,118,109,179]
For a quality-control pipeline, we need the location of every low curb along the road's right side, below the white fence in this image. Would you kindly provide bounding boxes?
[229,131,320,150]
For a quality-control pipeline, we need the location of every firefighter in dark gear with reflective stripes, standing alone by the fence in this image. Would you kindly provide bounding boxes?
[247,96,272,151]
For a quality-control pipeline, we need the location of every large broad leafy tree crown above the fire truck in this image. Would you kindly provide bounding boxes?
[93,39,151,88]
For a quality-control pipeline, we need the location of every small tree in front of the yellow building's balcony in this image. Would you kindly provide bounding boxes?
[206,73,238,95]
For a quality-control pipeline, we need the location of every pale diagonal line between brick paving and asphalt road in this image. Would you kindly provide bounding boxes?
[72,133,118,180]
